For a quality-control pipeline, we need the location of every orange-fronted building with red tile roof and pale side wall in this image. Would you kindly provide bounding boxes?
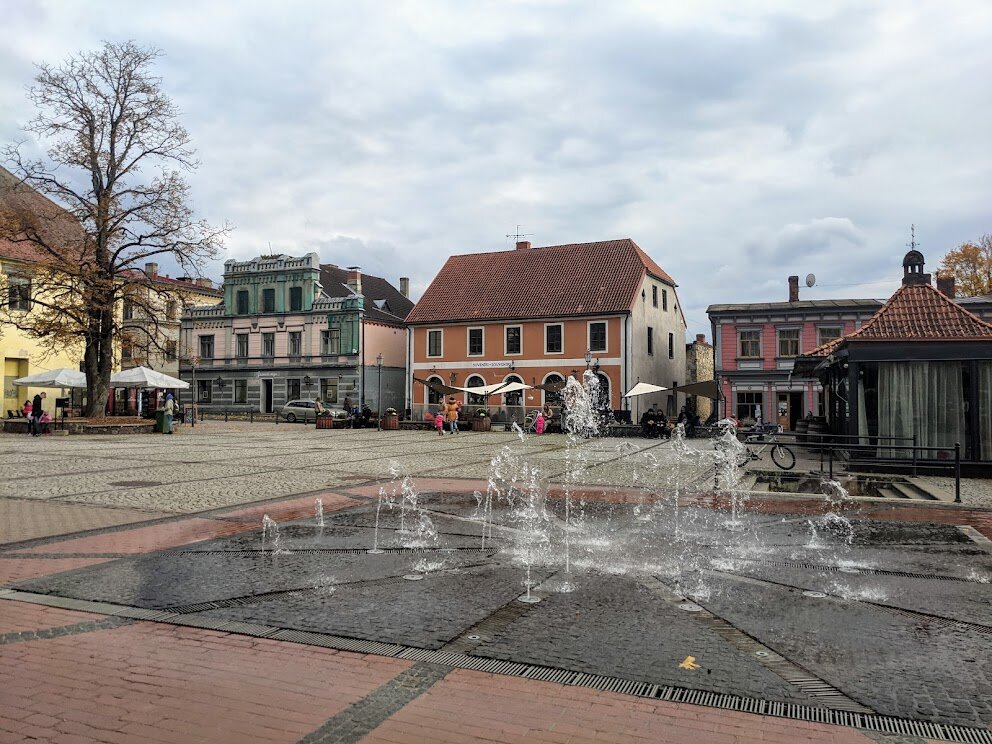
[407,238,686,424]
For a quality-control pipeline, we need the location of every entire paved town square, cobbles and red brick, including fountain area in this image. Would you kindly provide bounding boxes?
[0,421,992,742]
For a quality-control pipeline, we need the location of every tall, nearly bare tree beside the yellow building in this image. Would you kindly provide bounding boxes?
[0,42,228,416]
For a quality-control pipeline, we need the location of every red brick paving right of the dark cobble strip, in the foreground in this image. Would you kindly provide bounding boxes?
[362,670,870,744]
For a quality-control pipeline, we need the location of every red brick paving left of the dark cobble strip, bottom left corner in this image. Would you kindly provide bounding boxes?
[0,623,410,744]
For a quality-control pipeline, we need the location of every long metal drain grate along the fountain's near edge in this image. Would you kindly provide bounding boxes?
[0,590,992,744]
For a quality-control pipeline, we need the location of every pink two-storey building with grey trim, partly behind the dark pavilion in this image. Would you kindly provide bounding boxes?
[706,276,882,429]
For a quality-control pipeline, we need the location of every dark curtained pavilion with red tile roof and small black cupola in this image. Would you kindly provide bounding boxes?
[793,250,992,463]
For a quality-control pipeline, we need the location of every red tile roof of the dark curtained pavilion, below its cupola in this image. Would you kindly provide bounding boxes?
[804,284,992,357]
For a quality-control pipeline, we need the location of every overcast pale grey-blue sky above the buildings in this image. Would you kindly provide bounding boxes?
[0,0,992,337]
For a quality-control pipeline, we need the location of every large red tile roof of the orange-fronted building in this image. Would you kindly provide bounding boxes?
[407,238,676,324]
